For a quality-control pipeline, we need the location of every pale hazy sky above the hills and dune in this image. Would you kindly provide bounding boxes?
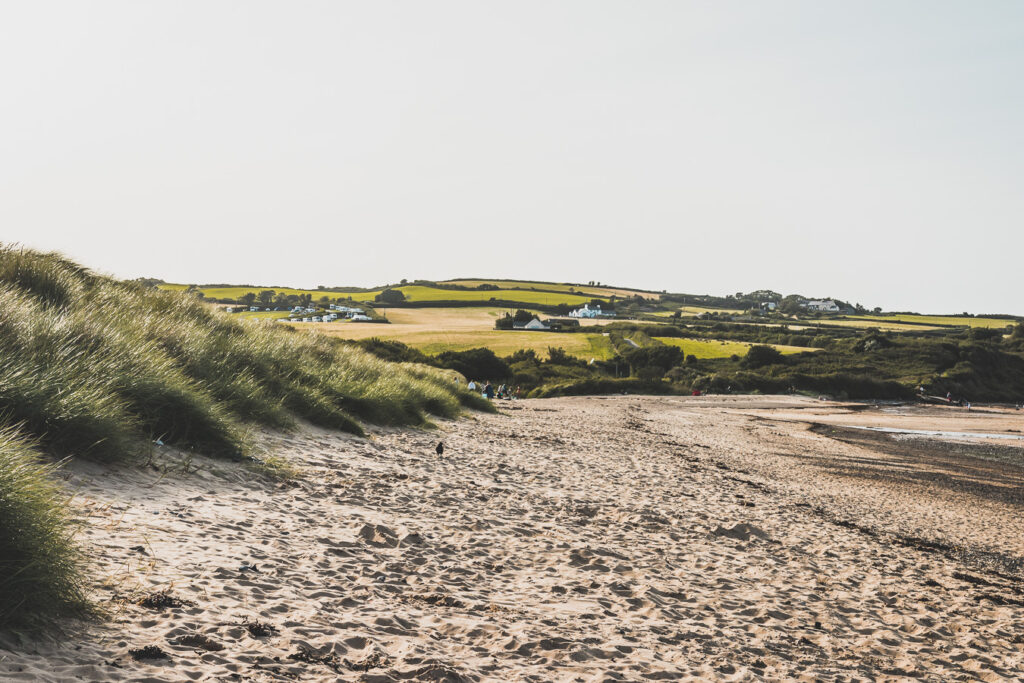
[0,0,1024,314]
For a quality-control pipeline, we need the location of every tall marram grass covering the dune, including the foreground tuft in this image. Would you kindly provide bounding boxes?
[0,248,493,627]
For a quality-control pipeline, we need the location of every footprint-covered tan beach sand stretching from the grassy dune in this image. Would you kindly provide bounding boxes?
[0,396,1024,681]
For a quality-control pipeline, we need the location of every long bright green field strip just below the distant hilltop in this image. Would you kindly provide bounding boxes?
[159,284,598,306]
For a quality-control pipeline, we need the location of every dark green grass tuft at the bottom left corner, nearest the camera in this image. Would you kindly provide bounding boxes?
[0,426,86,631]
